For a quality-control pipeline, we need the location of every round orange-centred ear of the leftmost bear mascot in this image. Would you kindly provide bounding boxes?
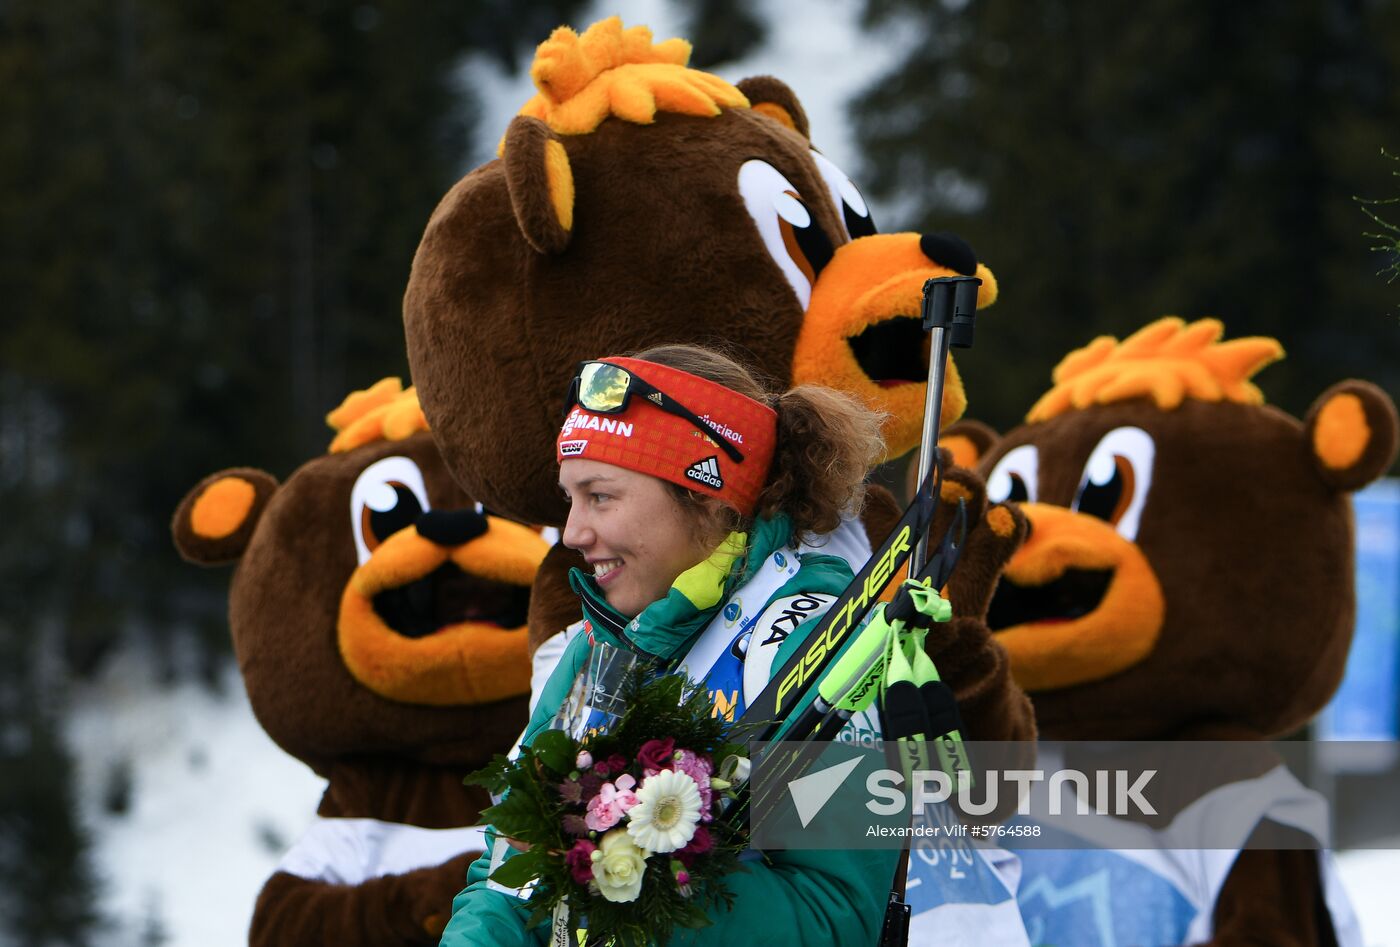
[171,466,277,566]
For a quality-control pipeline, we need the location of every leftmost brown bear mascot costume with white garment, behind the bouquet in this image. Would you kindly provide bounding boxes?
[172,380,547,947]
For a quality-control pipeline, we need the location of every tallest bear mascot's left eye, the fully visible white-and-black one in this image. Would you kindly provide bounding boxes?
[739,158,834,310]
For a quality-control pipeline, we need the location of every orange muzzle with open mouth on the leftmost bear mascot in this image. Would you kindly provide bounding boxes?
[336,517,549,706]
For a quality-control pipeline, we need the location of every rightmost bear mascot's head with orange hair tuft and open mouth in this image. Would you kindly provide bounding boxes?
[951,318,1397,740]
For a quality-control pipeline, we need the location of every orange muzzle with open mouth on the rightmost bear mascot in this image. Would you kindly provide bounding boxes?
[987,503,1166,692]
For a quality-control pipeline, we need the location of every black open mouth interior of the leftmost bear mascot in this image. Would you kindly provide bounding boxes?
[374,563,529,637]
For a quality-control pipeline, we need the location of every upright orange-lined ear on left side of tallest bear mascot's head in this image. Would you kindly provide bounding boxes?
[501,115,574,254]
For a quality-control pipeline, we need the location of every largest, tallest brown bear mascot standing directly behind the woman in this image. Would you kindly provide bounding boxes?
[394,12,1032,737]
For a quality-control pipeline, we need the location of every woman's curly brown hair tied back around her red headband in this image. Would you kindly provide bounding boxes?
[631,345,883,537]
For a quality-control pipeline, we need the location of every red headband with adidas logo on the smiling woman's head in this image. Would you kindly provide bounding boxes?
[554,359,778,516]
